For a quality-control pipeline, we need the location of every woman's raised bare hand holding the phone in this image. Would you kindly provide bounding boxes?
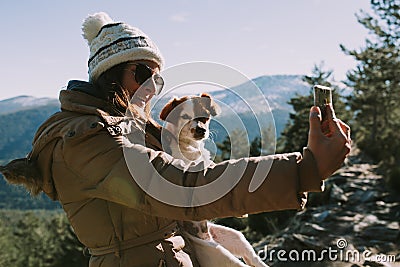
[307,105,351,179]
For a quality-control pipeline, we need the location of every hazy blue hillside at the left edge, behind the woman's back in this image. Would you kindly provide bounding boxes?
[0,101,60,209]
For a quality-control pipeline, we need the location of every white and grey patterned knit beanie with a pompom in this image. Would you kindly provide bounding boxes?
[82,12,164,81]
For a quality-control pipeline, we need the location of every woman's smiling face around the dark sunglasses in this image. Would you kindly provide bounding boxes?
[122,60,160,108]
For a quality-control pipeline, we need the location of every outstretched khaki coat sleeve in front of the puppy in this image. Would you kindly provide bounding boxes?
[58,127,321,220]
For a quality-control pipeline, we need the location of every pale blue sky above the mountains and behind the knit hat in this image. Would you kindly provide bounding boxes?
[0,0,370,100]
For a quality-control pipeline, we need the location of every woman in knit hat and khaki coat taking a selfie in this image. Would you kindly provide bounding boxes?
[2,13,350,267]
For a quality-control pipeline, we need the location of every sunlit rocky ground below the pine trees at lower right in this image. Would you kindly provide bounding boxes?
[254,150,400,267]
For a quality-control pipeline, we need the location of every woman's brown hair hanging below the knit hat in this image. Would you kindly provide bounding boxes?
[93,62,151,120]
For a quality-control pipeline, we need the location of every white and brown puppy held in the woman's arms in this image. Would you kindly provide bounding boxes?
[160,93,267,267]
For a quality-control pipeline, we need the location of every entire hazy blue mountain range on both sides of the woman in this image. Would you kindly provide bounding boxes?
[0,75,312,209]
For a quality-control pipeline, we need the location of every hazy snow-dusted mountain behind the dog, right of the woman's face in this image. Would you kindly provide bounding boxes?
[152,75,312,142]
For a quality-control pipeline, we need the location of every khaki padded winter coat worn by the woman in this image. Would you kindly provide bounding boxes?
[1,82,322,267]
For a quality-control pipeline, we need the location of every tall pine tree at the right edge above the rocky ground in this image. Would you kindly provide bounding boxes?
[341,0,400,189]
